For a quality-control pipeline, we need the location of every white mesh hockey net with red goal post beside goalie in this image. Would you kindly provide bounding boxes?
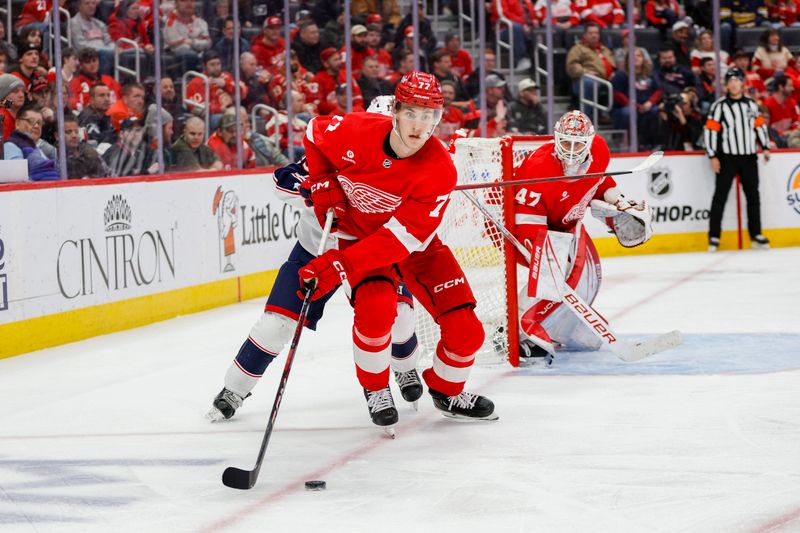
[416,136,551,366]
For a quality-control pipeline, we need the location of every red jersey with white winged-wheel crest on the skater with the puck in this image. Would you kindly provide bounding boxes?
[305,113,456,270]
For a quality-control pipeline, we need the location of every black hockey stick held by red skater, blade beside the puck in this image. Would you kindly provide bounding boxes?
[222,210,333,490]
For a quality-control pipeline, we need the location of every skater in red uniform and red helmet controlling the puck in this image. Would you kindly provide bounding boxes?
[300,72,496,426]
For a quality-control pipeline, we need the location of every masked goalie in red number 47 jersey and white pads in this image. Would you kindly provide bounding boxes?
[514,111,652,357]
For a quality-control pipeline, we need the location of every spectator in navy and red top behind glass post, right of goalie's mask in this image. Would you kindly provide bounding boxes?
[611,48,662,147]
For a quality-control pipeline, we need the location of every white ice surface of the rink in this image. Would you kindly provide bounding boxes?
[0,249,800,533]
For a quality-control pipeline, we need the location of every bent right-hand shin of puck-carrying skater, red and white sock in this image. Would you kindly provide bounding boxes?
[422,307,485,396]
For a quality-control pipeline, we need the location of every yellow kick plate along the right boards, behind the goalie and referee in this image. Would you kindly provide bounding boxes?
[593,228,800,257]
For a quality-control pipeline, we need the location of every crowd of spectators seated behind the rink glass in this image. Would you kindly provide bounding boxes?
[0,0,800,180]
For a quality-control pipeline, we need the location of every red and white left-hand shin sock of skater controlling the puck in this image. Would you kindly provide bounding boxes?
[353,276,397,391]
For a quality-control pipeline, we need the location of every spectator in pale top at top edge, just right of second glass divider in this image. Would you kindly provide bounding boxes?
[164,0,211,72]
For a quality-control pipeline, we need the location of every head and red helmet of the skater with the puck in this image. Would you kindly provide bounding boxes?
[392,71,444,151]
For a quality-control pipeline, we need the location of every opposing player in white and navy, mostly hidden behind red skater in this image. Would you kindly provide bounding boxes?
[206,97,423,421]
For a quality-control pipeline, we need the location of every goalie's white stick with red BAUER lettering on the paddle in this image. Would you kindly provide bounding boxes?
[461,190,681,362]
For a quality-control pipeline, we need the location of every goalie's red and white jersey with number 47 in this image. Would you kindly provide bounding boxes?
[514,135,616,256]
